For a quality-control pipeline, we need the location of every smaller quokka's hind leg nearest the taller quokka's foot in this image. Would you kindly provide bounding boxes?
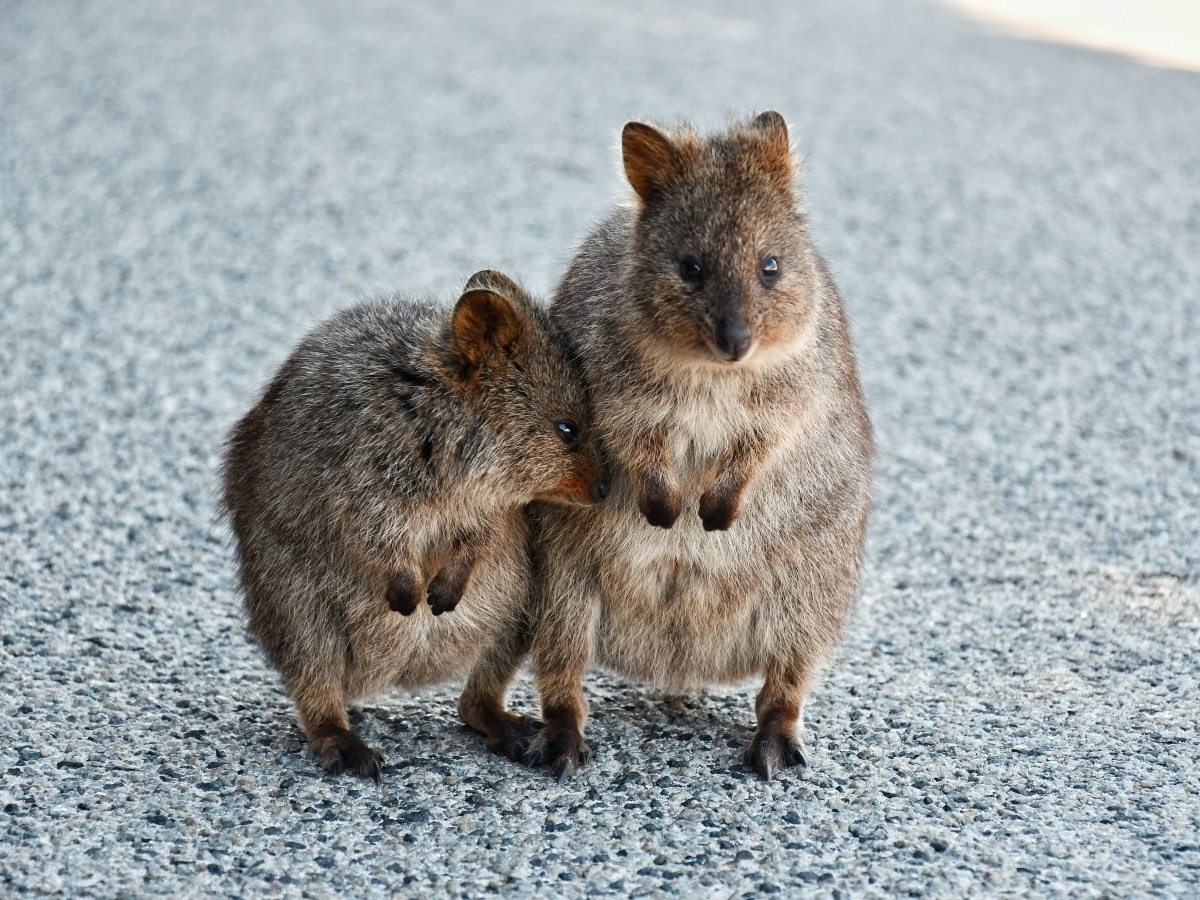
[458,628,541,763]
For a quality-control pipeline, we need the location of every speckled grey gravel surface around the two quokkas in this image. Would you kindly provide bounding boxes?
[0,0,1200,896]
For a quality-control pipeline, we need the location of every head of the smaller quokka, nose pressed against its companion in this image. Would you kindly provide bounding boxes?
[451,270,608,505]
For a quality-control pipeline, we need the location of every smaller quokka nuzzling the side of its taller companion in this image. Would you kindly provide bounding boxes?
[224,271,607,780]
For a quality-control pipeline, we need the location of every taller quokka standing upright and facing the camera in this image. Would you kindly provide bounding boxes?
[472,112,872,779]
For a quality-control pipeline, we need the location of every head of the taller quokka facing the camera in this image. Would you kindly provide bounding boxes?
[622,112,817,366]
